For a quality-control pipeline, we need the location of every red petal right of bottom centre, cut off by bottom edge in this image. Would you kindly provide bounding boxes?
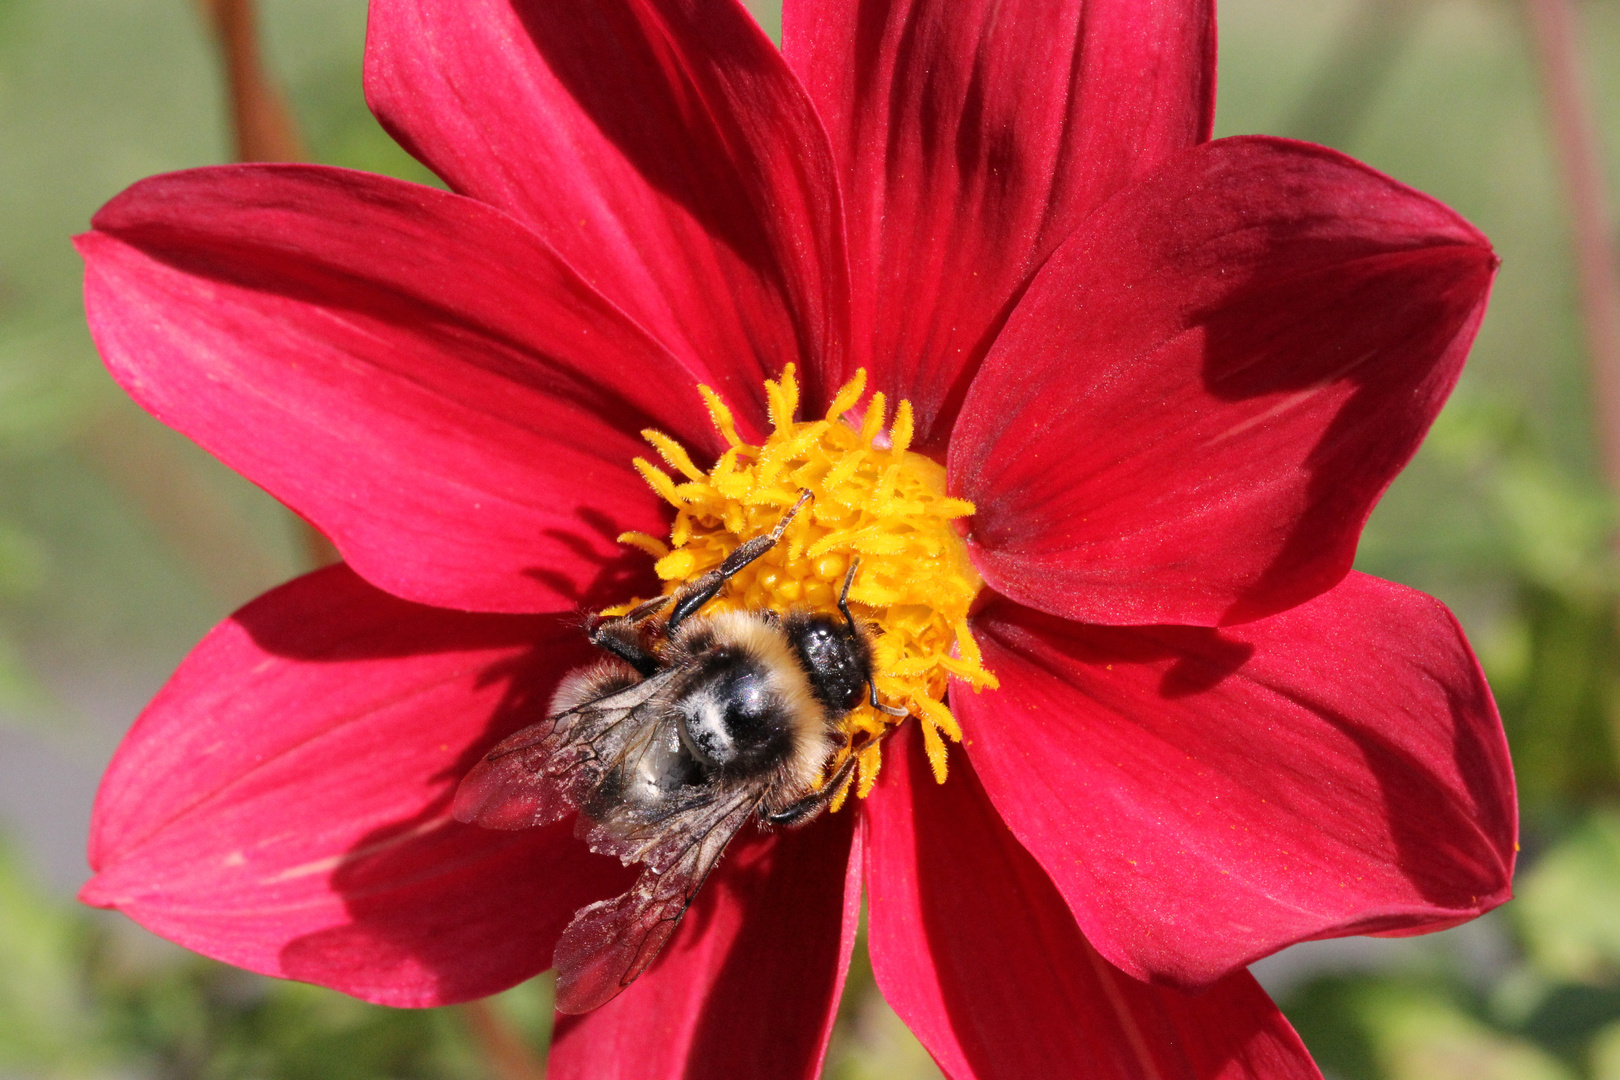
[867,732,1320,1080]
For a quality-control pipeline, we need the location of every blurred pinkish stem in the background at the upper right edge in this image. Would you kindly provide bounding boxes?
[1526,0,1620,491]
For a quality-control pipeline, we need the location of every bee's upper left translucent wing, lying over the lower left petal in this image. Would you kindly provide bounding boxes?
[450,669,676,829]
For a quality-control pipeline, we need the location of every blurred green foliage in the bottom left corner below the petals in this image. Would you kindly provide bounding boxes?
[0,848,551,1080]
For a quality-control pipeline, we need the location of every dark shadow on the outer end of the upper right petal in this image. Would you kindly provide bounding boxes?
[1192,241,1495,623]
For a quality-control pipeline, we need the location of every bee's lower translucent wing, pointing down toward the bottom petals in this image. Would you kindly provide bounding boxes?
[552,782,765,1014]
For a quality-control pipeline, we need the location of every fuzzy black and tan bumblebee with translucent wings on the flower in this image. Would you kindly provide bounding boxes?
[452,492,904,1014]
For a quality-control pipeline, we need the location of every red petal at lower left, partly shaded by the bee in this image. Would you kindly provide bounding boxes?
[83,567,630,1006]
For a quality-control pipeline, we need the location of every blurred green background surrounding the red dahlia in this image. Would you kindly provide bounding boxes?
[0,0,1620,1080]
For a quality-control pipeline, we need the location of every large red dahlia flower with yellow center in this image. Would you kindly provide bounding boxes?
[79,0,1515,1080]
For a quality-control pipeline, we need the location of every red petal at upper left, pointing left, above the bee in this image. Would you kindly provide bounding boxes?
[79,167,683,612]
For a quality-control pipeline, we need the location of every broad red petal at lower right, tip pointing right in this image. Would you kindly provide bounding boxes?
[951,575,1518,986]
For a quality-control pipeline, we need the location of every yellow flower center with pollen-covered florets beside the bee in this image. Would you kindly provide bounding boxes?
[606,364,996,810]
